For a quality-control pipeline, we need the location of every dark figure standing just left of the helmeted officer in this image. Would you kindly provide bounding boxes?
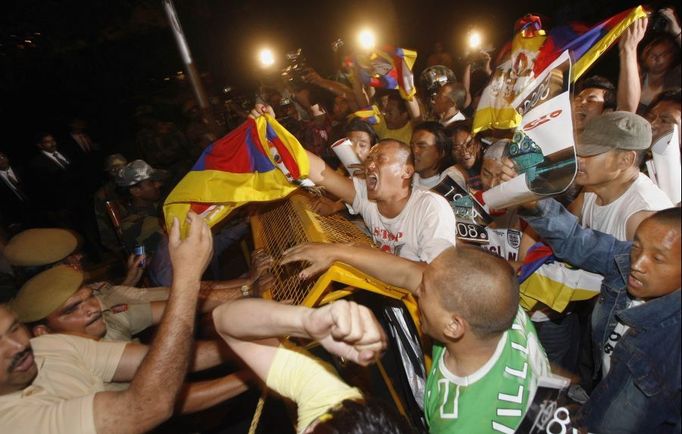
[93,154,128,252]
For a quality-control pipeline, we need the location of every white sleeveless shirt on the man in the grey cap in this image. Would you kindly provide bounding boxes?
[582,173,673,241]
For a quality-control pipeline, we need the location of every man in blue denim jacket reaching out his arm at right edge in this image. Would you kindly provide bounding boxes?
[520,199,682,433]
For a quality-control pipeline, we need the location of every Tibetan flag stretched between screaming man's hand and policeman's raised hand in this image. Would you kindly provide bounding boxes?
[163,115,312,232]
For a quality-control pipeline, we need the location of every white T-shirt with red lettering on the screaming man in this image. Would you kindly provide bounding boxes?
[353,178,457,262]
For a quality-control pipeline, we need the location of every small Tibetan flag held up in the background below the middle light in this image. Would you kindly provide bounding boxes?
[355,47,417,100]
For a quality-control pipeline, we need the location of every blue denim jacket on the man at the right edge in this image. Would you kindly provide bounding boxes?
[522,200,682,434]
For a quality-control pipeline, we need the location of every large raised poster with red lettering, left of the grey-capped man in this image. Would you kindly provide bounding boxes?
[483,51,576,209]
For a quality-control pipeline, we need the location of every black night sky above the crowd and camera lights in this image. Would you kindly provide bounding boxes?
[0,0,652,159]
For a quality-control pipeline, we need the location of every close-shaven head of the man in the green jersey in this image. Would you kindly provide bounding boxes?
[431,245,519,338]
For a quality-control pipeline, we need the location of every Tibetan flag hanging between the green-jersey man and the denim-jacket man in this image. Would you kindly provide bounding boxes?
[518,243,604,313]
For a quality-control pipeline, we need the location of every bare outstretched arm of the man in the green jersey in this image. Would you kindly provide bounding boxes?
[282,243,426,293]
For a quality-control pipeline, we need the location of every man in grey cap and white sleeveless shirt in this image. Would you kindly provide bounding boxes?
[571,111,673,240]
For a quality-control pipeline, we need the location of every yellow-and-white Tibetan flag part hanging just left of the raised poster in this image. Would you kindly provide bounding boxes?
[472,15,547,134]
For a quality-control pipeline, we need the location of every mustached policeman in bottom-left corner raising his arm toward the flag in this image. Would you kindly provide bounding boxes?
[0,213,251,434]
